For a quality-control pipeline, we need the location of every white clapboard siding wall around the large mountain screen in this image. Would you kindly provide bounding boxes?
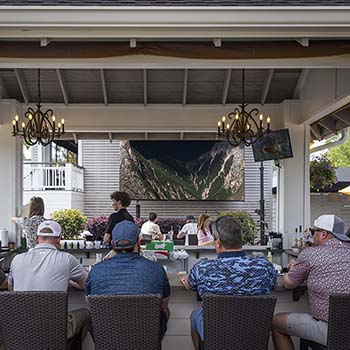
[82,140,272,227]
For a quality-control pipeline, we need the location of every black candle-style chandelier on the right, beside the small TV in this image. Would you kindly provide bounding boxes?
[217,69,271,147]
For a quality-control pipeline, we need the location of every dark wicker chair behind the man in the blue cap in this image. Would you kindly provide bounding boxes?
[88,294,161,350]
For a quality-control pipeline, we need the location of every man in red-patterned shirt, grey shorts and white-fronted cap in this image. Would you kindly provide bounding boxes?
[272,215,350,350]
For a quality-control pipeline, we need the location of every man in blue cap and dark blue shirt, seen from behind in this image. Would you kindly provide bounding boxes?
[86,220,170,337]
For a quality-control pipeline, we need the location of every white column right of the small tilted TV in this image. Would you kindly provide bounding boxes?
[277,101,310,249]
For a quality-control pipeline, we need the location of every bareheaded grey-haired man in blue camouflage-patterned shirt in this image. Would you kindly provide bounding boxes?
[182,216,277,349]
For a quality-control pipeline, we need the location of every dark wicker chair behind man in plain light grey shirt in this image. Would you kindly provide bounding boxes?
[0,292,68,350]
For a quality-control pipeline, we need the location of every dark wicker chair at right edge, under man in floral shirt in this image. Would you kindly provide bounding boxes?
[300,294,350,350]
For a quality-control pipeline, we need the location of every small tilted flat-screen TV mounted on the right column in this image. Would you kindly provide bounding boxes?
[253,129,293,162]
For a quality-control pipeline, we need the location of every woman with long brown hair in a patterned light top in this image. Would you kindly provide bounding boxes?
[11,197,45,248]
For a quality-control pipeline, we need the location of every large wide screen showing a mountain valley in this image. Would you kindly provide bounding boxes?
[119,141,245,201]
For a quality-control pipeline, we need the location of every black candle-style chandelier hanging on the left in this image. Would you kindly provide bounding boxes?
[12,69,64,146]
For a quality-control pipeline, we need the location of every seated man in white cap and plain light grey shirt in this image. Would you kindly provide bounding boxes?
[9,220,90,339]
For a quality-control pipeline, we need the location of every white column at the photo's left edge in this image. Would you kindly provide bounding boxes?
[0,101,23,244]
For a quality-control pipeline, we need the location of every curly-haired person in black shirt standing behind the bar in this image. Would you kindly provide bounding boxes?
[103,191,135,244]
